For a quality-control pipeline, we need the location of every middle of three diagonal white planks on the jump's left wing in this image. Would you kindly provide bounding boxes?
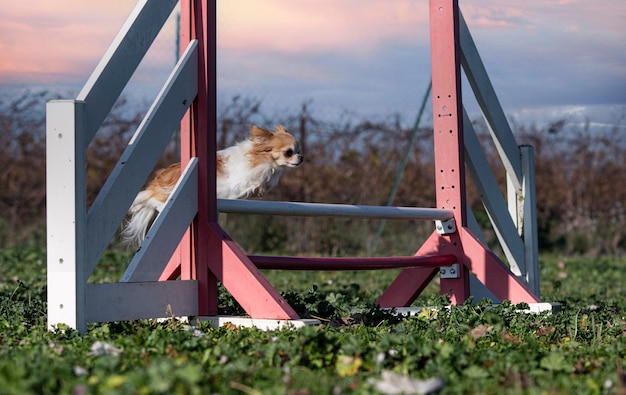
[86,40,198,273]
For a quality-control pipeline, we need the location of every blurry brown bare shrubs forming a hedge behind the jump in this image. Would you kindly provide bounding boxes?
[0,92,626,255]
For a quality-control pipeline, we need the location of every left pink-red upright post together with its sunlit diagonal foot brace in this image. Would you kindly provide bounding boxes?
[176,0,298,319]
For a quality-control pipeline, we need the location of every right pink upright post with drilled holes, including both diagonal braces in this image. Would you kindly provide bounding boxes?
[378,0,539,307]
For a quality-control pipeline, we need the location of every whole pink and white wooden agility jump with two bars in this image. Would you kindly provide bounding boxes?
[46,0,539,333]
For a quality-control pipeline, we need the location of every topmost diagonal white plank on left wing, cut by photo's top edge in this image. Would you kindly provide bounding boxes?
[77,0,178,149]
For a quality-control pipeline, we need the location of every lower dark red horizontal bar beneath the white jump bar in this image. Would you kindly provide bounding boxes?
[248,255,457,270]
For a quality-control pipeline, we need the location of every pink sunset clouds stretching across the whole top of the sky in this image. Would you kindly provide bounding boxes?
[0,0,626,87]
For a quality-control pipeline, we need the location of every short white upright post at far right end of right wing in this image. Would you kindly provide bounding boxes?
[520,145,540,297]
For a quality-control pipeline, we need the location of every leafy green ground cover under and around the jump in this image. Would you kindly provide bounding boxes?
[0,246,626,394]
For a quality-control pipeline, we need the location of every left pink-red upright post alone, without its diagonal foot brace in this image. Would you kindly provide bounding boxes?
[178,0,217,315]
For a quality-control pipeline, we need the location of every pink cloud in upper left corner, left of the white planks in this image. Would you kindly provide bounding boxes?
[0,0,147,83]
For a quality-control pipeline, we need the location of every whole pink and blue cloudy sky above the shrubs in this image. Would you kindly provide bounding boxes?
[0,0,626,131]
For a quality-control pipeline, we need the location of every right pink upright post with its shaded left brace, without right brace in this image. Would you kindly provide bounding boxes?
[378,0,469,307]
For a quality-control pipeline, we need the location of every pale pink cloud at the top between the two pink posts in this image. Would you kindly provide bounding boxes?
[218,0,428,52]
